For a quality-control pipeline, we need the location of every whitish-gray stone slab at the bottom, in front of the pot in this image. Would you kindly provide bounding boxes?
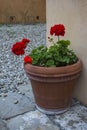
[8,110,59,130]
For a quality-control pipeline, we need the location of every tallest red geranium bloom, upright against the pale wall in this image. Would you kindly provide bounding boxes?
[50,24,65,36]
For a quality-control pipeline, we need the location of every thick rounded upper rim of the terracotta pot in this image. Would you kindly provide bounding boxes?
[24,59,82,77]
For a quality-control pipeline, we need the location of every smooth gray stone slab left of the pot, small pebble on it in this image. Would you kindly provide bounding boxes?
[0,92,35,119]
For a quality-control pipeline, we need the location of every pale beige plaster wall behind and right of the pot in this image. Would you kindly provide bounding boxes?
[46,0,87,105]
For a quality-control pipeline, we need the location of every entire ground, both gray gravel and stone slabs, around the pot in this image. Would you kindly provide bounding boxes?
[0,24,87,130]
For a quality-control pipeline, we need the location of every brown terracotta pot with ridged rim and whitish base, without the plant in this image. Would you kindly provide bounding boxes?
[24,59,82,114]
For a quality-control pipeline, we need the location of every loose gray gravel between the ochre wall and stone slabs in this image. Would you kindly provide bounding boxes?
[0,24,46,96]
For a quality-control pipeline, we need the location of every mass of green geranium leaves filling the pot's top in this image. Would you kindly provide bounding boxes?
[30,40,78,67]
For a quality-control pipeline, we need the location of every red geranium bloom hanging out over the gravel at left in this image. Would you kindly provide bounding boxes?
[11,38,30,55]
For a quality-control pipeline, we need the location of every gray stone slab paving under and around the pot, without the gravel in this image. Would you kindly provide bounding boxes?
[0,82,87,130]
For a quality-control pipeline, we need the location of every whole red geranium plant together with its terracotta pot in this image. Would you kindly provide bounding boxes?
[12,24,82,114]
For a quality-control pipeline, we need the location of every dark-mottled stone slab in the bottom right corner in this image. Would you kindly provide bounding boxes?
[52,104,87,130]
